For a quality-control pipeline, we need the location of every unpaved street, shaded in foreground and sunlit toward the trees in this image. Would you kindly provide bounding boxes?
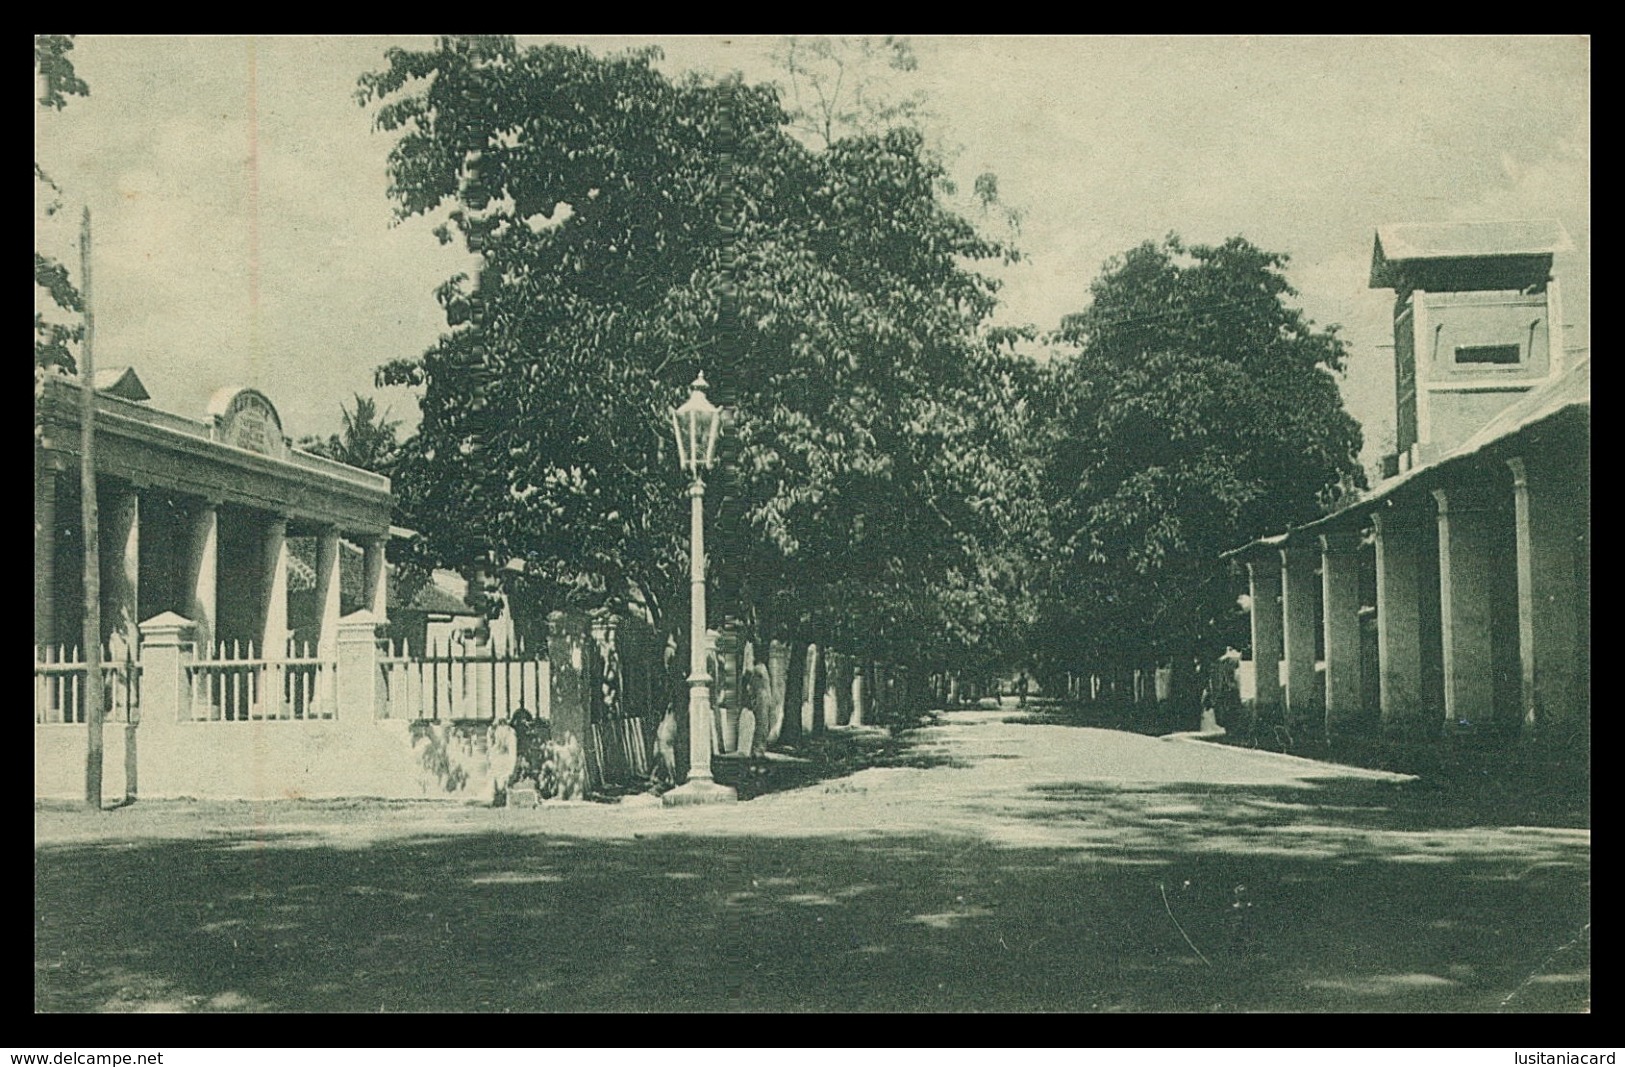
[36,708,1591,1012]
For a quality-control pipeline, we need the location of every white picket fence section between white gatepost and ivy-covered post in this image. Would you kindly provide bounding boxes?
[379,640,549,719]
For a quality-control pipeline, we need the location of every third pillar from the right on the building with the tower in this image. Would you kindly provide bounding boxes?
[1372,512,1424,729]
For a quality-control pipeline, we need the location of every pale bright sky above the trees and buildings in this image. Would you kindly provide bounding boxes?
[34,36,1591,474]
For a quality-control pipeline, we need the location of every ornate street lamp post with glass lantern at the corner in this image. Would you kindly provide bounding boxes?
[663,374,739,807]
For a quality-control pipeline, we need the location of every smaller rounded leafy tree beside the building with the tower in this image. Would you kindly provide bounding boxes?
[1042,235,1363,682]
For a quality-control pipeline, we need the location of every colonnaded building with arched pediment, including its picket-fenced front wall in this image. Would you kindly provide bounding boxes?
[34,369,739,802]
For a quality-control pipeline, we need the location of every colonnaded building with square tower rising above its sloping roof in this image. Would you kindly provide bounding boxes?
[1229,221,1591,744]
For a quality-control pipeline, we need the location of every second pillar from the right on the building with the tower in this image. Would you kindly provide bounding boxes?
[1433,489,1497,724]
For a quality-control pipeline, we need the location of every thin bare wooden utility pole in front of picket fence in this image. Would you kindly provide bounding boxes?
[80,206,104,812]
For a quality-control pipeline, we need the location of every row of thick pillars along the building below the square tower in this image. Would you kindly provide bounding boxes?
[1248,458,1586,732]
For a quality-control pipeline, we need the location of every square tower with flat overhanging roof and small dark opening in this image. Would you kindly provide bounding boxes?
[1370,219,1571,474]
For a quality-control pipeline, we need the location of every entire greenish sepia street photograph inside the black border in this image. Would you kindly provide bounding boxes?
[34,34,1601,1013]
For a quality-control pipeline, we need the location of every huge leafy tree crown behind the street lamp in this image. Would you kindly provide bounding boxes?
[361,37,1033,665]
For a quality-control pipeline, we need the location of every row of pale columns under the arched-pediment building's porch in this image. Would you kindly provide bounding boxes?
[34,473,388,661]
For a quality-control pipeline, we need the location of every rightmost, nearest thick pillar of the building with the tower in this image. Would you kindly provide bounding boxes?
[1508,454,1589,732]
